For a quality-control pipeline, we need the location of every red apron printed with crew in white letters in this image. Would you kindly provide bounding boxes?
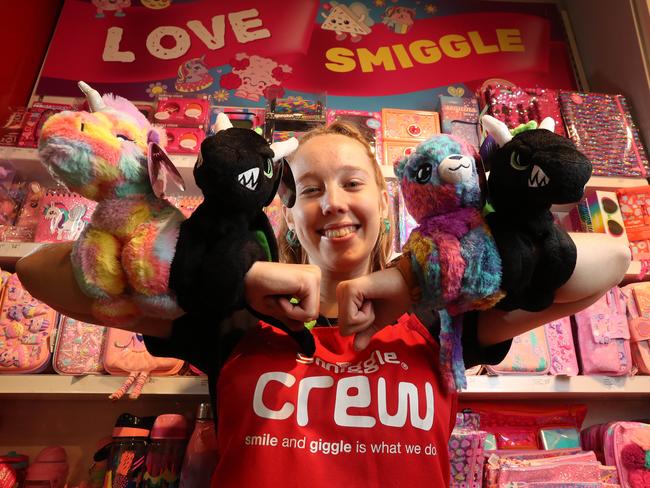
[212,315,457,488]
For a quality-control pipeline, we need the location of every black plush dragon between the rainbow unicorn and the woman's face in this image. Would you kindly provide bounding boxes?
[169,128,315,356]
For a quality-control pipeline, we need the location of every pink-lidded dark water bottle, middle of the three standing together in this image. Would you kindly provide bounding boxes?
[142,414,187,488]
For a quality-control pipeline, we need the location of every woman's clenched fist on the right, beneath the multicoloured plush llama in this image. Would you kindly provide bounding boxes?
[336,268,411,351]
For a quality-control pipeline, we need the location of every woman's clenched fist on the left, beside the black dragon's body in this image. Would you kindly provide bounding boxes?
[244,261,321,330]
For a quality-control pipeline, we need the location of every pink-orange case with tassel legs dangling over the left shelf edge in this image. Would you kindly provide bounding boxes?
[104,327,183,400]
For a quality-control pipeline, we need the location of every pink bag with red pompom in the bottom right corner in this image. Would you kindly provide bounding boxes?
[603,422,650,488]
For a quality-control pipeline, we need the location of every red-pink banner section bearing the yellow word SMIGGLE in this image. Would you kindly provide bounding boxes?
[285,13,549,96]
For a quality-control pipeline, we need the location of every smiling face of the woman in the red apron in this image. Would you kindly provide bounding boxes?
[286,134,388,275]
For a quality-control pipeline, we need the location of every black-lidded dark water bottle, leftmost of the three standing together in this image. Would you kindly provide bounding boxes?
[104,413,155,488]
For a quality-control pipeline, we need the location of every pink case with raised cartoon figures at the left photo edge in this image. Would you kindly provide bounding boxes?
[0,274,58,374]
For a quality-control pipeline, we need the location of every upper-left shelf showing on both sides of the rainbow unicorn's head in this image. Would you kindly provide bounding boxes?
[0,146,201,195]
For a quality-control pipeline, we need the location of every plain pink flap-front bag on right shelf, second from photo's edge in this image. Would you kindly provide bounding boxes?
[575,286,632,376]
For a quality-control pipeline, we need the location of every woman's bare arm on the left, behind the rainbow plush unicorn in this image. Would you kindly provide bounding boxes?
[16,242,171,337]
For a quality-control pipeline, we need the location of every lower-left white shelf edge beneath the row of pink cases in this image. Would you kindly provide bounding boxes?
[0,374,208,396]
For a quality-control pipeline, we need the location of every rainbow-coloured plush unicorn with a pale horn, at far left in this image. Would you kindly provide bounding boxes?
[39,84,184,325]
